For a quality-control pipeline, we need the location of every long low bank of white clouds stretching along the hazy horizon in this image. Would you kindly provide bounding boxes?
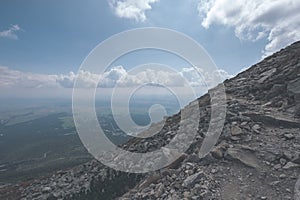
[0,66,231,88]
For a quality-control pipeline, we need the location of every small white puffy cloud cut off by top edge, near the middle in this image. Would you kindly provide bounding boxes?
[109,0,159,22]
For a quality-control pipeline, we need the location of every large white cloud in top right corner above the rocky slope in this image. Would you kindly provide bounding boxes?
[198,0,300,56]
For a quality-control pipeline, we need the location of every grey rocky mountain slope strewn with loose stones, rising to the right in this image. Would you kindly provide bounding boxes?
[0,42,300,200]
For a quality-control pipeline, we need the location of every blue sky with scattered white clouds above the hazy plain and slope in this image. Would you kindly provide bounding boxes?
[0,0,300,98]
